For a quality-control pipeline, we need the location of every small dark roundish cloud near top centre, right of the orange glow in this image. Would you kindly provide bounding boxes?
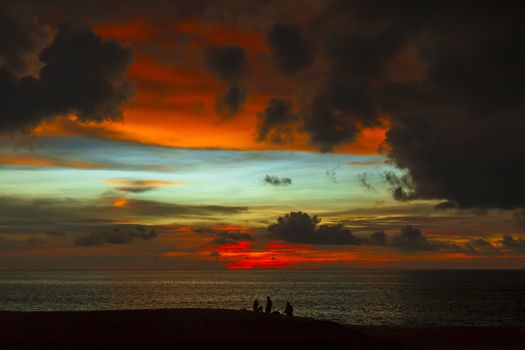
[266,23,315,74]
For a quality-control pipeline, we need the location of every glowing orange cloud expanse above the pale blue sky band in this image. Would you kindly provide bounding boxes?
[29,21,388,154]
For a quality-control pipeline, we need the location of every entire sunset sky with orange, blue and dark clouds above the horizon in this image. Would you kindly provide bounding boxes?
[0,0,525,269]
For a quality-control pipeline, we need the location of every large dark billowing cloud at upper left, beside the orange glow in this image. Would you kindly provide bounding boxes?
[0,24,132,132]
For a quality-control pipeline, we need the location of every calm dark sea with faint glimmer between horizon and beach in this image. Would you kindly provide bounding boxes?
[0,270,525,326]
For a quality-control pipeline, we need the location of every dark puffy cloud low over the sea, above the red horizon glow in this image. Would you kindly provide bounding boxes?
[268,211,361,245]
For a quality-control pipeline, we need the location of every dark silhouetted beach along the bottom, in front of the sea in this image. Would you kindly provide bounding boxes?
[0,309,525,350]
